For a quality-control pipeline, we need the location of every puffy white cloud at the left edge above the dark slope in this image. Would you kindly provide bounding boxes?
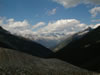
[0,18,30,33]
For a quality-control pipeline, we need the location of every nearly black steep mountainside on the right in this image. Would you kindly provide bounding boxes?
[55,27,100,71]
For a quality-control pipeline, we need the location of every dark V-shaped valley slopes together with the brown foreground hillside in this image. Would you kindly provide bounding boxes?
[0,27,100,75]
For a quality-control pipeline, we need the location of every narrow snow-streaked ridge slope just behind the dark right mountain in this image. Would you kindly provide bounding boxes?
[53,27,93,52]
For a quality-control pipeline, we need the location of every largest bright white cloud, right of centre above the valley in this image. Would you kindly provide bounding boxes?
[38,19,87,34]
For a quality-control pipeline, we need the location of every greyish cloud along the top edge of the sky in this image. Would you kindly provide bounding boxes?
[53,0,100,8]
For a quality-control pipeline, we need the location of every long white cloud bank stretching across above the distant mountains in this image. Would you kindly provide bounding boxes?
[0,18,87,35]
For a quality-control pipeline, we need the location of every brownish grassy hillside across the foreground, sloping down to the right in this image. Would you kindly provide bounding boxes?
[0,48,100,75]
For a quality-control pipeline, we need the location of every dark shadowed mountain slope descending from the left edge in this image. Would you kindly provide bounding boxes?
[0,27,53,58]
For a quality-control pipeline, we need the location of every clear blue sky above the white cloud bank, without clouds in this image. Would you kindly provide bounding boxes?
[0,0,100,25]
